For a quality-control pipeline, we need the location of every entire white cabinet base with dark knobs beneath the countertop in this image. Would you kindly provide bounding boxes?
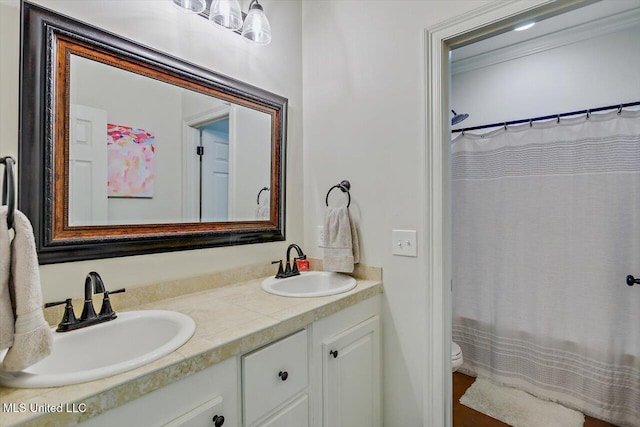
[75,296,382,427]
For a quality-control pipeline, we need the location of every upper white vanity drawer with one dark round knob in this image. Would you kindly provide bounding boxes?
[242,330,309,426]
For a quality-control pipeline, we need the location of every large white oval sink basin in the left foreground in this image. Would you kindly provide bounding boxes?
[0,310,196,388]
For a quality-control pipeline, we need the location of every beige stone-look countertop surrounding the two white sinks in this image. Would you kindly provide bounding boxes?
[0,268,382,427]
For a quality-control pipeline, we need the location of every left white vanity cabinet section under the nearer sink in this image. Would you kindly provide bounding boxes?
[80,358,240,427]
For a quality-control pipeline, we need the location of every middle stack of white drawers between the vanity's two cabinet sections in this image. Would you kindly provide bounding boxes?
[242,329,309,427]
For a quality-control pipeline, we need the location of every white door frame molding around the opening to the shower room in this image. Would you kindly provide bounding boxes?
[420,0,593,427]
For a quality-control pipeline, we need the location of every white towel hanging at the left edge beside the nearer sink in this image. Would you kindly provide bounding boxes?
[0,208,53,372]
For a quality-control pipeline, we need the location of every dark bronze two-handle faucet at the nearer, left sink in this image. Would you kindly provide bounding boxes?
[44,271,125,332]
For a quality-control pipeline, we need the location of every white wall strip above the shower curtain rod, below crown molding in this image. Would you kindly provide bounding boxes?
[451,23,640,133]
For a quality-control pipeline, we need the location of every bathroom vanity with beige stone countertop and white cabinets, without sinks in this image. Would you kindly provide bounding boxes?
[0,268,382,427]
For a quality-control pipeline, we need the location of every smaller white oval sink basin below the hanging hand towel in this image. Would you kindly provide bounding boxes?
[262,271,356,298]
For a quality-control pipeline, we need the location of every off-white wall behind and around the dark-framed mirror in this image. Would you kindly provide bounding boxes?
[0,0,303,301]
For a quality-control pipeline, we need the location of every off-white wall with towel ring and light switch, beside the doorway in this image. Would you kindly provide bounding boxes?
[302,0,496,427]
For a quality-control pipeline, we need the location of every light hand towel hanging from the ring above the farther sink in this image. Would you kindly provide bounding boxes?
[323,207,360,273]
